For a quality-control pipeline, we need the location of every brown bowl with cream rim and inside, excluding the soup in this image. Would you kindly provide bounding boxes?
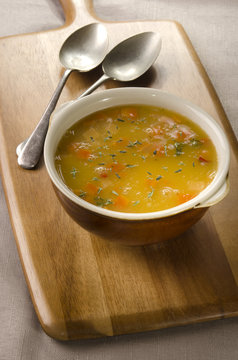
[44,87,230,244]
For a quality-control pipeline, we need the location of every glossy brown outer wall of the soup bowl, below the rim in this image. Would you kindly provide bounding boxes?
[53,184,208,246]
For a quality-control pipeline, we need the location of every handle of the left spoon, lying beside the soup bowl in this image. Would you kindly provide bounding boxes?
[18,69,73,170]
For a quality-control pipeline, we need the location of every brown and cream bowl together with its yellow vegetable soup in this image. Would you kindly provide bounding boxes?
[44,88,230,245]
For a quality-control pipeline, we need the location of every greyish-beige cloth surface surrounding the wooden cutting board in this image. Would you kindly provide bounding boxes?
[0,0,238,359]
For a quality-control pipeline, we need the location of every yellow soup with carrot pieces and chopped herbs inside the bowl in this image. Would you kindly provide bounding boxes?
[55,105,217,213]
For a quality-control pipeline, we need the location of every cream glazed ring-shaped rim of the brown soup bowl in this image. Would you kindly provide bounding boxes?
[44,87,230,220]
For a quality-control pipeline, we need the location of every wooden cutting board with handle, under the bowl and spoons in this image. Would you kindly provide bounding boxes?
[0,0,238,340]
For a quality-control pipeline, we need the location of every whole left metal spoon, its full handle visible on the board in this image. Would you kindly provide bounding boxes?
[16,23,108,169]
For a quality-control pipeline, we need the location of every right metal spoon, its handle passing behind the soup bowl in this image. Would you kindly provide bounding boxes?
[18,32,161,169]
